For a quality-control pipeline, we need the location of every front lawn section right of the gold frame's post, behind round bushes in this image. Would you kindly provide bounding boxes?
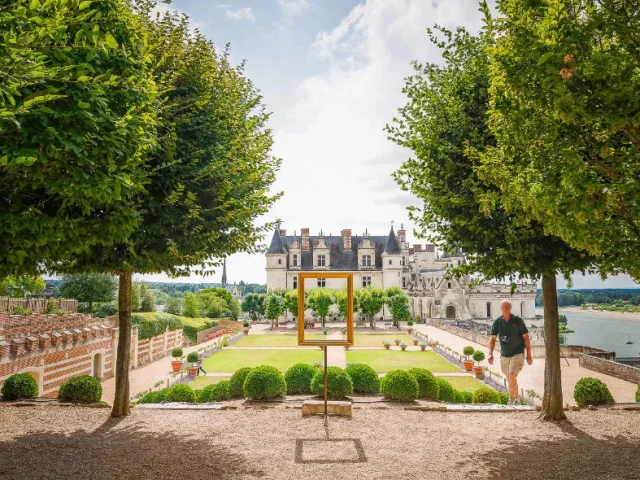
[347,350,460,373]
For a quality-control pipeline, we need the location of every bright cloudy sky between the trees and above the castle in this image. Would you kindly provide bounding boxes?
[138,0,637,288]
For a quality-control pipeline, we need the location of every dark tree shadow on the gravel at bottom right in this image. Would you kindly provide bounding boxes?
[458,422,640,480]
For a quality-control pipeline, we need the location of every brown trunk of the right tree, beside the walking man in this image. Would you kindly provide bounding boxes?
[540,274,567,422]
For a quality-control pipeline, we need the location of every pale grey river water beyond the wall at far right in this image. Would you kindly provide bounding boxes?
[536,309,640,357]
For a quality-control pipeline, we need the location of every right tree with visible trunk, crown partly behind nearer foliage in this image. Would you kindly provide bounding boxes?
[387,21,594,420]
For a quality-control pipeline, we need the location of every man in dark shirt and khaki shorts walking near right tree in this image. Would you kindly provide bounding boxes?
[488,300,533,405]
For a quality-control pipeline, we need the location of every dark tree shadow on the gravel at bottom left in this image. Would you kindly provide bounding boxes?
[0,420,264,480]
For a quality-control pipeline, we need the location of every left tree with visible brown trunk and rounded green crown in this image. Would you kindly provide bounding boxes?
[56,8,280,417]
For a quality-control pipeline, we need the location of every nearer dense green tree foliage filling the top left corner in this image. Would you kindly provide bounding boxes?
[0,0,156,278]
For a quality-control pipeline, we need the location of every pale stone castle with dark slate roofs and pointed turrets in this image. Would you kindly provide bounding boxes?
[266,226,537,321]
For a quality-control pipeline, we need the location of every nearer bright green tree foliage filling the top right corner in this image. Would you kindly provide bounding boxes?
[480,0,640,279]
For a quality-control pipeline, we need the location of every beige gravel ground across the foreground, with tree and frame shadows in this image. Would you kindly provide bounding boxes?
[0,401,640,480]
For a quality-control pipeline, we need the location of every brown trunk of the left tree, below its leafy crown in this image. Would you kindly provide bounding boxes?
[111,272,132,418]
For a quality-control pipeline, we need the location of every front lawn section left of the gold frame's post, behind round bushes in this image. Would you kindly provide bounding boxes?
[202,347,322,373]
